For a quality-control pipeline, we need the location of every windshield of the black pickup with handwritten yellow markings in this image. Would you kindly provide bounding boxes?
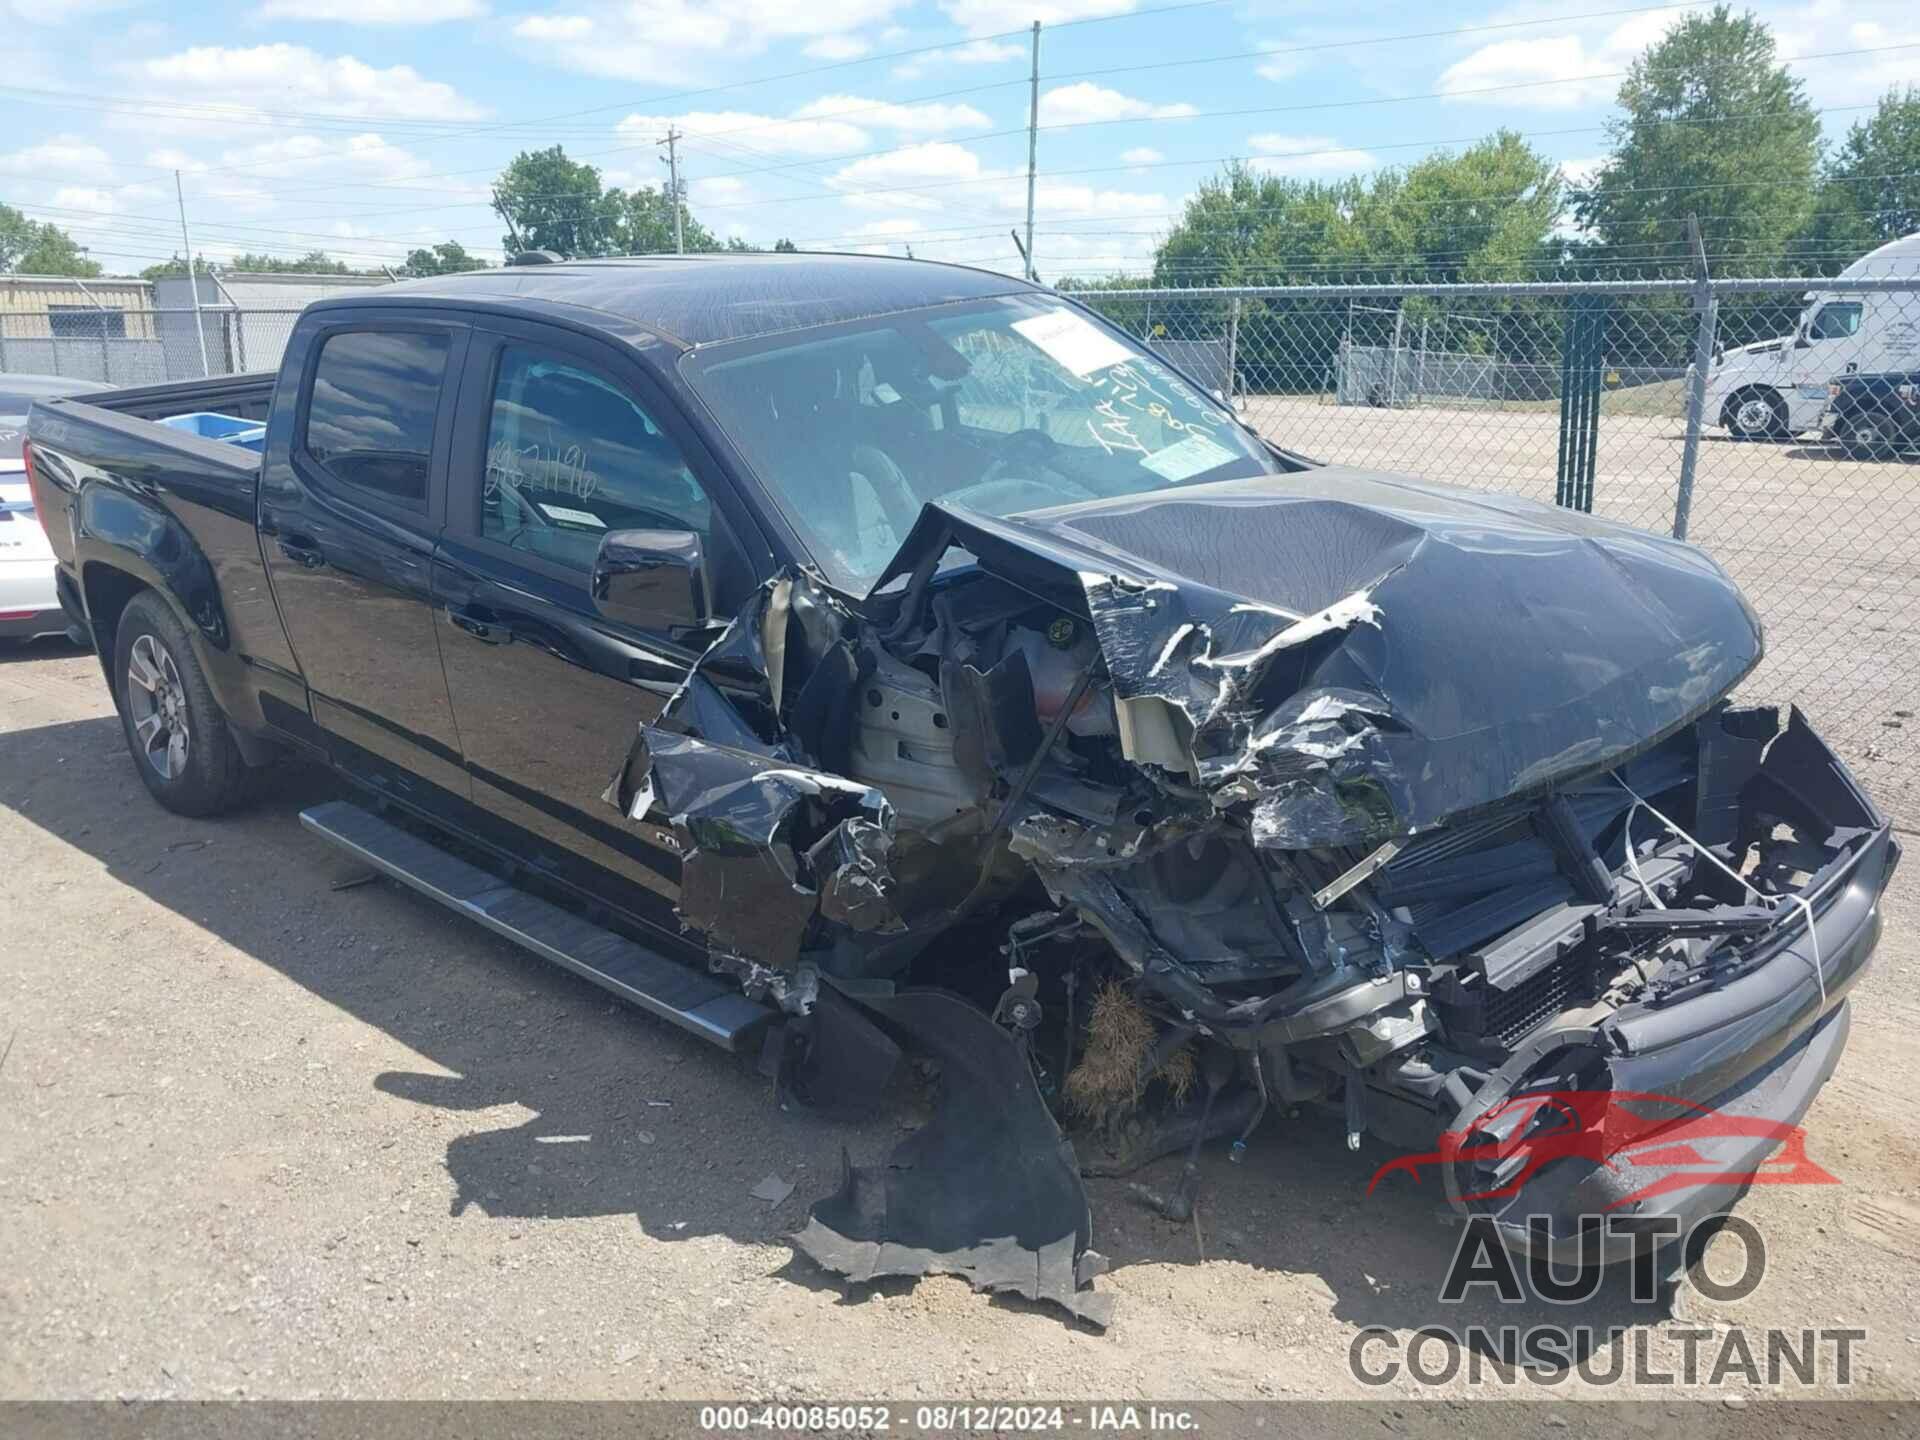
[684,296,1281,593]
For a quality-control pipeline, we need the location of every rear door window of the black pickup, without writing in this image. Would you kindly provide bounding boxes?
[301,330,447,513]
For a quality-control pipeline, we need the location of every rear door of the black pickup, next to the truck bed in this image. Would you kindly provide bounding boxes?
[259,305,468,818]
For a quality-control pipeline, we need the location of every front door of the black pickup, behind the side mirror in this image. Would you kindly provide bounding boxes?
[434,321,766,933]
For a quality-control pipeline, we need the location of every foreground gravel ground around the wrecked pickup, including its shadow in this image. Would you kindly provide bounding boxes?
[0,647,1920,1400]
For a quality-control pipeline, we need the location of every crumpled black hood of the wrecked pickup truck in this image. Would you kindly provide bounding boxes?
[870,467,1761,847]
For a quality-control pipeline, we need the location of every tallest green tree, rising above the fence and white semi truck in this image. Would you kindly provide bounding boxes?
[1574,6,1820,271]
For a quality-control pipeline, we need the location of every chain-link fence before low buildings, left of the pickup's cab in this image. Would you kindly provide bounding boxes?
[0,305,300,386]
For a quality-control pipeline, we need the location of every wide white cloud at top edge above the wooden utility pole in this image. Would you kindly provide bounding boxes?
[513,0,908,84]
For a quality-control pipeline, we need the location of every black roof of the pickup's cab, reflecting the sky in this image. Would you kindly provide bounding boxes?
[345,252,1039,346]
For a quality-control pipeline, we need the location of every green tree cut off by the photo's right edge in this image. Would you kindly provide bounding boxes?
[1799,86,1920,271]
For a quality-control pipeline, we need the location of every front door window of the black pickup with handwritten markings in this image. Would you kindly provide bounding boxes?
[480,346,714,574]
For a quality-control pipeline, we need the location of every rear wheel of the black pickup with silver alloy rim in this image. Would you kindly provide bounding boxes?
[113,589,246,816]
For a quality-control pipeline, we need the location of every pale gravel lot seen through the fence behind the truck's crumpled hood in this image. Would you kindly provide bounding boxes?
[1246,397,1920,814]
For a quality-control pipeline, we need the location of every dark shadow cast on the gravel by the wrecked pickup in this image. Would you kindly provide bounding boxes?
[0,716,1667,1359]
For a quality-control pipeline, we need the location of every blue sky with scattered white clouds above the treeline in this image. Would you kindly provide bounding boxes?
[0,0,1920,280]
